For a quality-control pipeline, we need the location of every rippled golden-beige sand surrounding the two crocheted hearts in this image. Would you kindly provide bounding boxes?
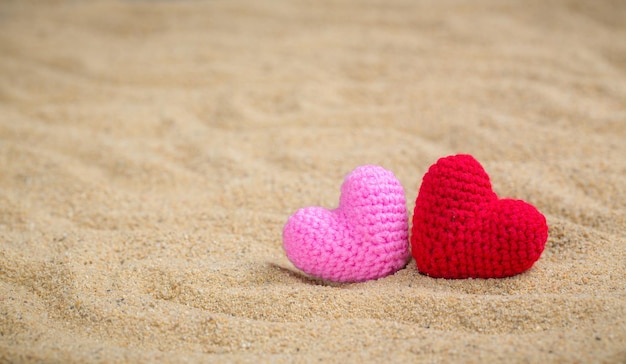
[0,0,626,363]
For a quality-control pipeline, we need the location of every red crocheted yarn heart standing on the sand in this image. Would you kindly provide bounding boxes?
[411,155,548,278]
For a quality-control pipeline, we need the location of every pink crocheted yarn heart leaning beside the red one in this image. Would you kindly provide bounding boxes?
[283,165,410,282]
